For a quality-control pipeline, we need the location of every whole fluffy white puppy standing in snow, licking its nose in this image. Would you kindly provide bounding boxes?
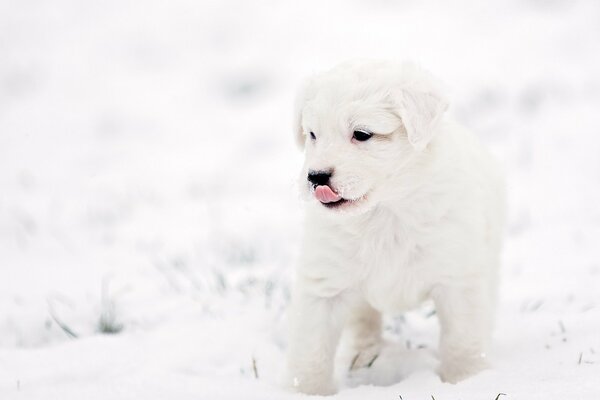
[288,61,504,395]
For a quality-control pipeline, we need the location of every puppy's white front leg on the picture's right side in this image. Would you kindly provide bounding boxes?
[433,283,494,383]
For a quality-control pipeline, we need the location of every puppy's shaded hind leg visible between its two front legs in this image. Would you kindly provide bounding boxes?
[347,301,382,369]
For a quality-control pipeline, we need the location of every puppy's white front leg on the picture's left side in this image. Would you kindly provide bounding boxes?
[287,288,348,395]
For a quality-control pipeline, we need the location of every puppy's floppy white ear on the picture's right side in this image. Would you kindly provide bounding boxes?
[393,66,448,151]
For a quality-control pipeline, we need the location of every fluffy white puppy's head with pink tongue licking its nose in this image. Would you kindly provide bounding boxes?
[295,61,447,214]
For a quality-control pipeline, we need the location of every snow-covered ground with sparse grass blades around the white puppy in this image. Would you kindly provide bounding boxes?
[0,0,600,400]
